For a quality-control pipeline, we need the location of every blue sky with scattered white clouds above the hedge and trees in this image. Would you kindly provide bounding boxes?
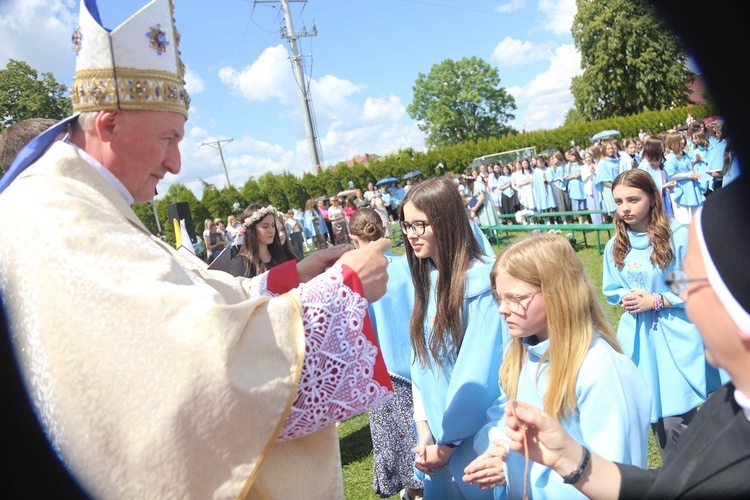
[0,0,580,196]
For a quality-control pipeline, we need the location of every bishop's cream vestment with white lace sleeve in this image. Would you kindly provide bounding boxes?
[0,142,388,498]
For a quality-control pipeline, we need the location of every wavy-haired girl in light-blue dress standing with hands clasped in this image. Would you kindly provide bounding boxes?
[602,169,721,460]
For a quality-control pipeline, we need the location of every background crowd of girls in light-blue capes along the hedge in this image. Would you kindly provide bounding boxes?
[474,120,738,225]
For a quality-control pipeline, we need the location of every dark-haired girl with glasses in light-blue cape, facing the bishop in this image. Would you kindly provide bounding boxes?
[399,177,508,499]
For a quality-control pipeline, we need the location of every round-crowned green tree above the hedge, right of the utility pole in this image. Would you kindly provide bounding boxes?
[407,57,516,147]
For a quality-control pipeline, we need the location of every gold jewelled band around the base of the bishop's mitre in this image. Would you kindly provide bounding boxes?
[70,68,190,115]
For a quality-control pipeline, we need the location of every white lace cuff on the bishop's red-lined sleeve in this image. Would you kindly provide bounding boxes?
[279,265,391,441]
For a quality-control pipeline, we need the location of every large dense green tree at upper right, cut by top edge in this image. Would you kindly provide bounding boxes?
[571,0,695,120]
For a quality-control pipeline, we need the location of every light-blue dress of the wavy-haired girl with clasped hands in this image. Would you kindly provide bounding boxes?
[602,219,722,423]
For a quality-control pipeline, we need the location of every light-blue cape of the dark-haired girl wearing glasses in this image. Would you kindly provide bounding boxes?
[412,259,508,499]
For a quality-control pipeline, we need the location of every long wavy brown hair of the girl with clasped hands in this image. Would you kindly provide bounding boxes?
[612,169,675,269]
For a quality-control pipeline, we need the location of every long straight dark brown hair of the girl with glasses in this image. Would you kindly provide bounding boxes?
[398,177,483,366]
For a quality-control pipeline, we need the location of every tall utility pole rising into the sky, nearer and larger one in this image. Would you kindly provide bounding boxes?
[255,0,323,172]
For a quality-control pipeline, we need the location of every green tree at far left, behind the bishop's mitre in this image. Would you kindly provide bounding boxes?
[0,59,73,132]
